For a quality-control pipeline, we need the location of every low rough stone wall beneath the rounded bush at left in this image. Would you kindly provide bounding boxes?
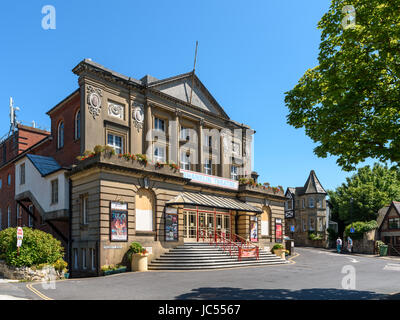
[0,260,65,281]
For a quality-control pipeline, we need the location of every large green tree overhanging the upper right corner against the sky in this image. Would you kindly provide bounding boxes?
[285,0,400,171]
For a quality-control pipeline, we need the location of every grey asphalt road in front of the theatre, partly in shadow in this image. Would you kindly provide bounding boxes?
[0,248,400,300]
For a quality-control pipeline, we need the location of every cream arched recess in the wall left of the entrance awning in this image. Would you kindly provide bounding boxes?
[135,189,155,231]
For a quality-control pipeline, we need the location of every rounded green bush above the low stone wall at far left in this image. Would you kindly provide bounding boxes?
[0,227,64,267]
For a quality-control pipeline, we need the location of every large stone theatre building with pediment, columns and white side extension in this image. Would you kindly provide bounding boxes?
[7,60,286,276]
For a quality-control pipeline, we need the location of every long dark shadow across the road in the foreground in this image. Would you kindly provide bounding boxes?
[176,287,387,300]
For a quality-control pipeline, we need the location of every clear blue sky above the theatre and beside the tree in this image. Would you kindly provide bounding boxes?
[0,0,376,189]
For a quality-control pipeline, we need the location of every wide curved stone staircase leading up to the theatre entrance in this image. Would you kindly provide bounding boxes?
[148,242,288,270]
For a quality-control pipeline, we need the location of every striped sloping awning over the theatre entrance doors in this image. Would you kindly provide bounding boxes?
[166,192,262,213]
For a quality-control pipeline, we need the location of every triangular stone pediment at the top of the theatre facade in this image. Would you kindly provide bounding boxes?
[149,72,229,119]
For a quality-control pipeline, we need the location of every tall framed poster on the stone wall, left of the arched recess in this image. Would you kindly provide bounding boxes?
[110,202,128,241]
